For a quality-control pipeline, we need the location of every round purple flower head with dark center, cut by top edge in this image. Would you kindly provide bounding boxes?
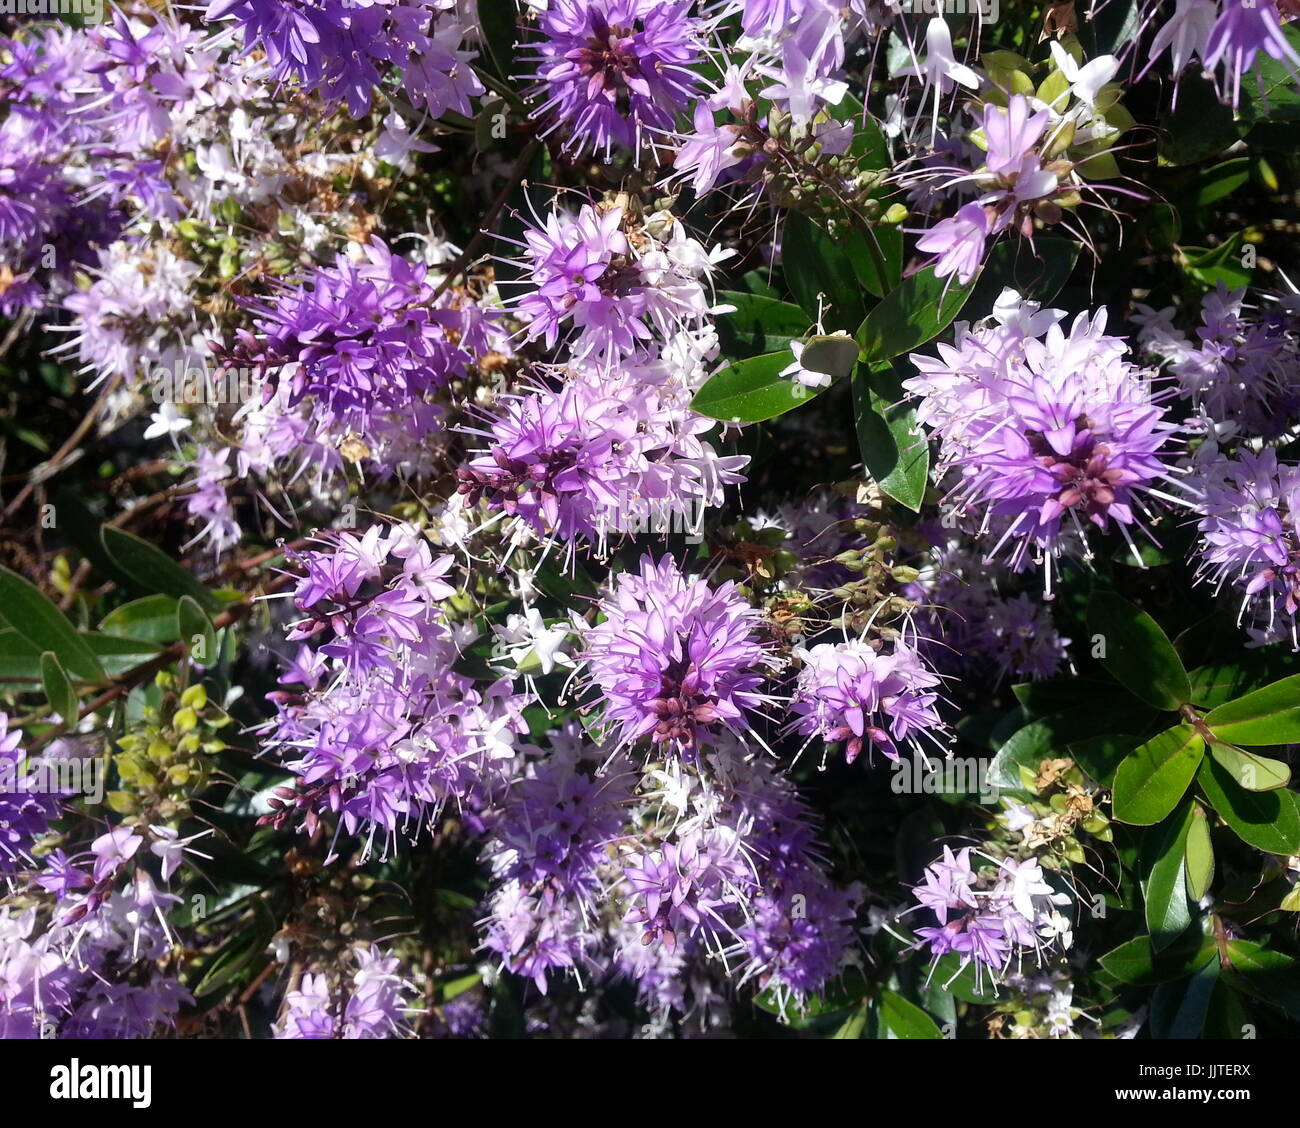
[529,0,705,157]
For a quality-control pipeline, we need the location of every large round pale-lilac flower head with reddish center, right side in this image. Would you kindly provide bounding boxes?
[905,291,1174,570]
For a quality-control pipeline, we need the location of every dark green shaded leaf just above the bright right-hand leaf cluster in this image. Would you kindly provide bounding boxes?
[1088,591,1192,710]
